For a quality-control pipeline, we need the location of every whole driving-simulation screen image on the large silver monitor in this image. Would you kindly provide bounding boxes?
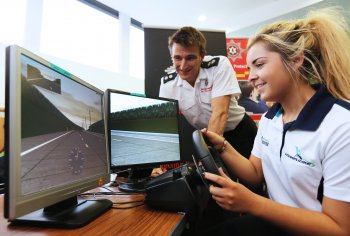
[21,55,108,195]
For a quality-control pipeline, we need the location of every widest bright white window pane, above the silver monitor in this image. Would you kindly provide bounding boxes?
[40,0,119,72]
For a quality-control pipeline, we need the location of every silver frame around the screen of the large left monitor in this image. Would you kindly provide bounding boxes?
[4,45,110,221]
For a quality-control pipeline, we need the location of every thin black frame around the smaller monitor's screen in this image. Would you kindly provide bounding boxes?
[105,89,182,173]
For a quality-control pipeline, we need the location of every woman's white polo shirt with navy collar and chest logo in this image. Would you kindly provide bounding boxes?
[252,87,350,211]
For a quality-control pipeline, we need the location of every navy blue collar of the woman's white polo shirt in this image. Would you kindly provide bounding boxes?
[265,86,337,131]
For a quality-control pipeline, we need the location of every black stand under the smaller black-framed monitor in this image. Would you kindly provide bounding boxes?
[117,167,153,193]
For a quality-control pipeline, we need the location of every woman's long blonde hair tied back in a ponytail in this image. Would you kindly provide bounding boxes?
[248,7,350,100]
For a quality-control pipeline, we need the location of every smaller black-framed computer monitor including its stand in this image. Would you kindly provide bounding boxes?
[106,89,181,191]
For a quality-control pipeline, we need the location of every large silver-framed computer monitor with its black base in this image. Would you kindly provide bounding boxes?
[4,45,112,228]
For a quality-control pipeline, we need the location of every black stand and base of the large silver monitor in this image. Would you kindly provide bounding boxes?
[11,196,113,228]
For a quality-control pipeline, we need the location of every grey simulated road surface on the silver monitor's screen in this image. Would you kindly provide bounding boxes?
[21,130,107,194]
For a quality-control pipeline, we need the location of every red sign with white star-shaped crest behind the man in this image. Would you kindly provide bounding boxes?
[226,38,249,80]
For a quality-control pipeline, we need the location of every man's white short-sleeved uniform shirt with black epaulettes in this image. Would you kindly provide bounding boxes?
[159,56,245,131]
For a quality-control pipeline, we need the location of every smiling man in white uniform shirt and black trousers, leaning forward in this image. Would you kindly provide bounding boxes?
[159,27,257,158]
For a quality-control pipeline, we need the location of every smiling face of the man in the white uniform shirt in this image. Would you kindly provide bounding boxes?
[171,43,203,86]
